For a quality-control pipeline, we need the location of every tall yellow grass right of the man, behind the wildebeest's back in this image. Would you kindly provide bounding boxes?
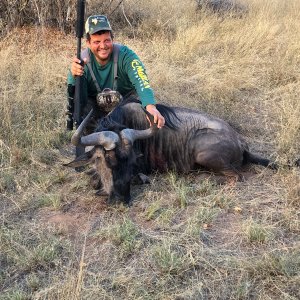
[121,0,300,161]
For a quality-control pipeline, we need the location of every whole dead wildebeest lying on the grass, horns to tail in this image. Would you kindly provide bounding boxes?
[67,102,276,204]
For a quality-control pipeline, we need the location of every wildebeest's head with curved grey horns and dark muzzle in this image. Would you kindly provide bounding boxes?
[66,111,158,204]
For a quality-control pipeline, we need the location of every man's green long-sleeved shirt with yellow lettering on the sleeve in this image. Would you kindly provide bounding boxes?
[67,45,156,107]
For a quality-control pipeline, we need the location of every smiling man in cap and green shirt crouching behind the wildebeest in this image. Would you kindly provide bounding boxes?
[68,15,165,133]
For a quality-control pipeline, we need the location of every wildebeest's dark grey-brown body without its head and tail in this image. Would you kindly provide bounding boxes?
[99,103,248,173]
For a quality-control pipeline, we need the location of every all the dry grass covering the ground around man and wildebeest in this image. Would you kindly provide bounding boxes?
[0,0,300,300]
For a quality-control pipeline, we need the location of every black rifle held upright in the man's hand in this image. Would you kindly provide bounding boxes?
[74,0,85,128]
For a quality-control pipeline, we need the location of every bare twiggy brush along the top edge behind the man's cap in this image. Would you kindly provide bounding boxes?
[0,0,197,36]
